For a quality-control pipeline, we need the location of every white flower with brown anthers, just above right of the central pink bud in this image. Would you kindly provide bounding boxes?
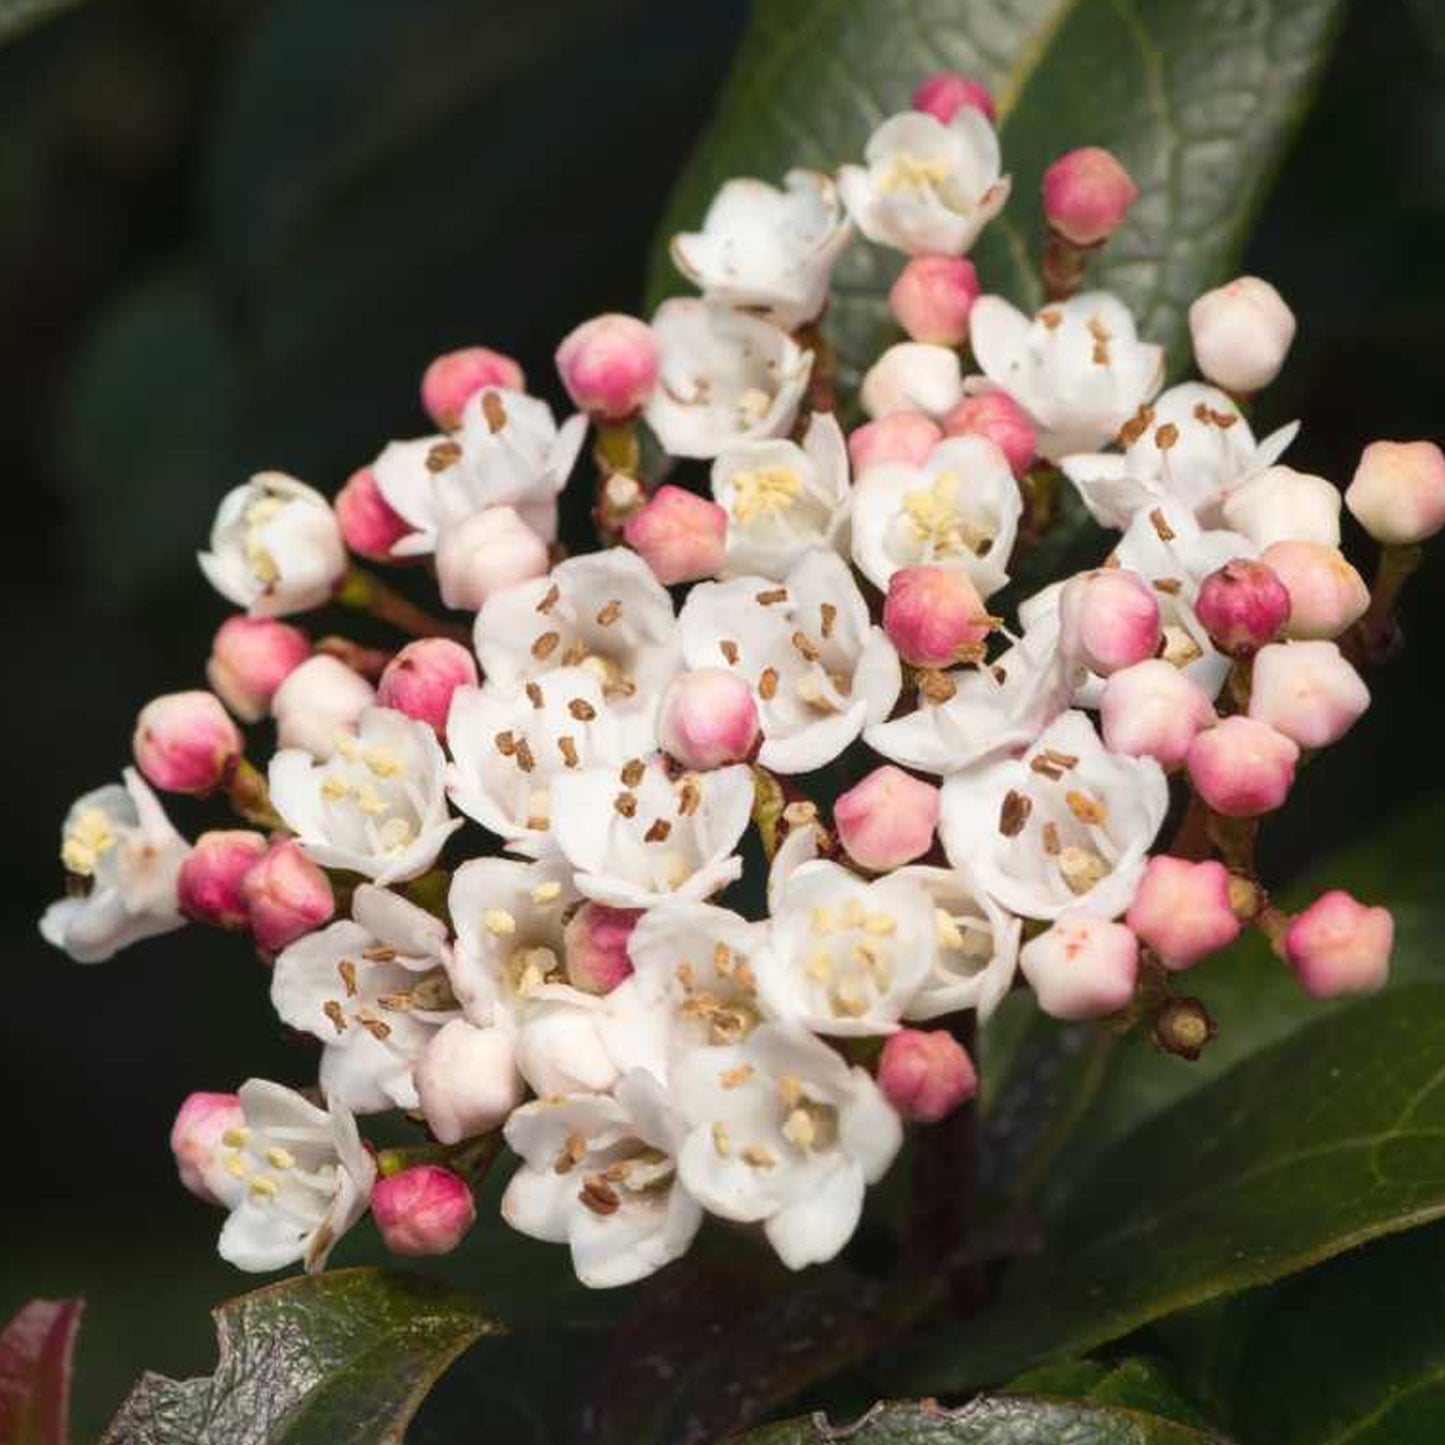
[681,549,902,773]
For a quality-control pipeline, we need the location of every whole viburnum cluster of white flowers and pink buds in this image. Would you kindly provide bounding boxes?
[40,75,1445,1286]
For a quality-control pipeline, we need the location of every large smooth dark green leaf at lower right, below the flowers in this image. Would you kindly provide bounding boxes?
[903,984,1445,1394]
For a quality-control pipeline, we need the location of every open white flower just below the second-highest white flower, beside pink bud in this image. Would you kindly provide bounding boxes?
[643,298,812,457]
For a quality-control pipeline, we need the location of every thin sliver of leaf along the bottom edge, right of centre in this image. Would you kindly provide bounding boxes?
[716,1396,1222,1445]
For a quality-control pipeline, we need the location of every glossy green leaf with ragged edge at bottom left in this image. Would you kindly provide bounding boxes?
[103,1269,501,1445]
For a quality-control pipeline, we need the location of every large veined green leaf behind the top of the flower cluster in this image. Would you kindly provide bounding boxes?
[652,0,1344,381]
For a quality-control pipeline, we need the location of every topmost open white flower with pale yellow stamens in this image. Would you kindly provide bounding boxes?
[838,105,1009,256]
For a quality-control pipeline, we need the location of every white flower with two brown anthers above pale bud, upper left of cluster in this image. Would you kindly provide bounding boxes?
[371,386,587,556]
